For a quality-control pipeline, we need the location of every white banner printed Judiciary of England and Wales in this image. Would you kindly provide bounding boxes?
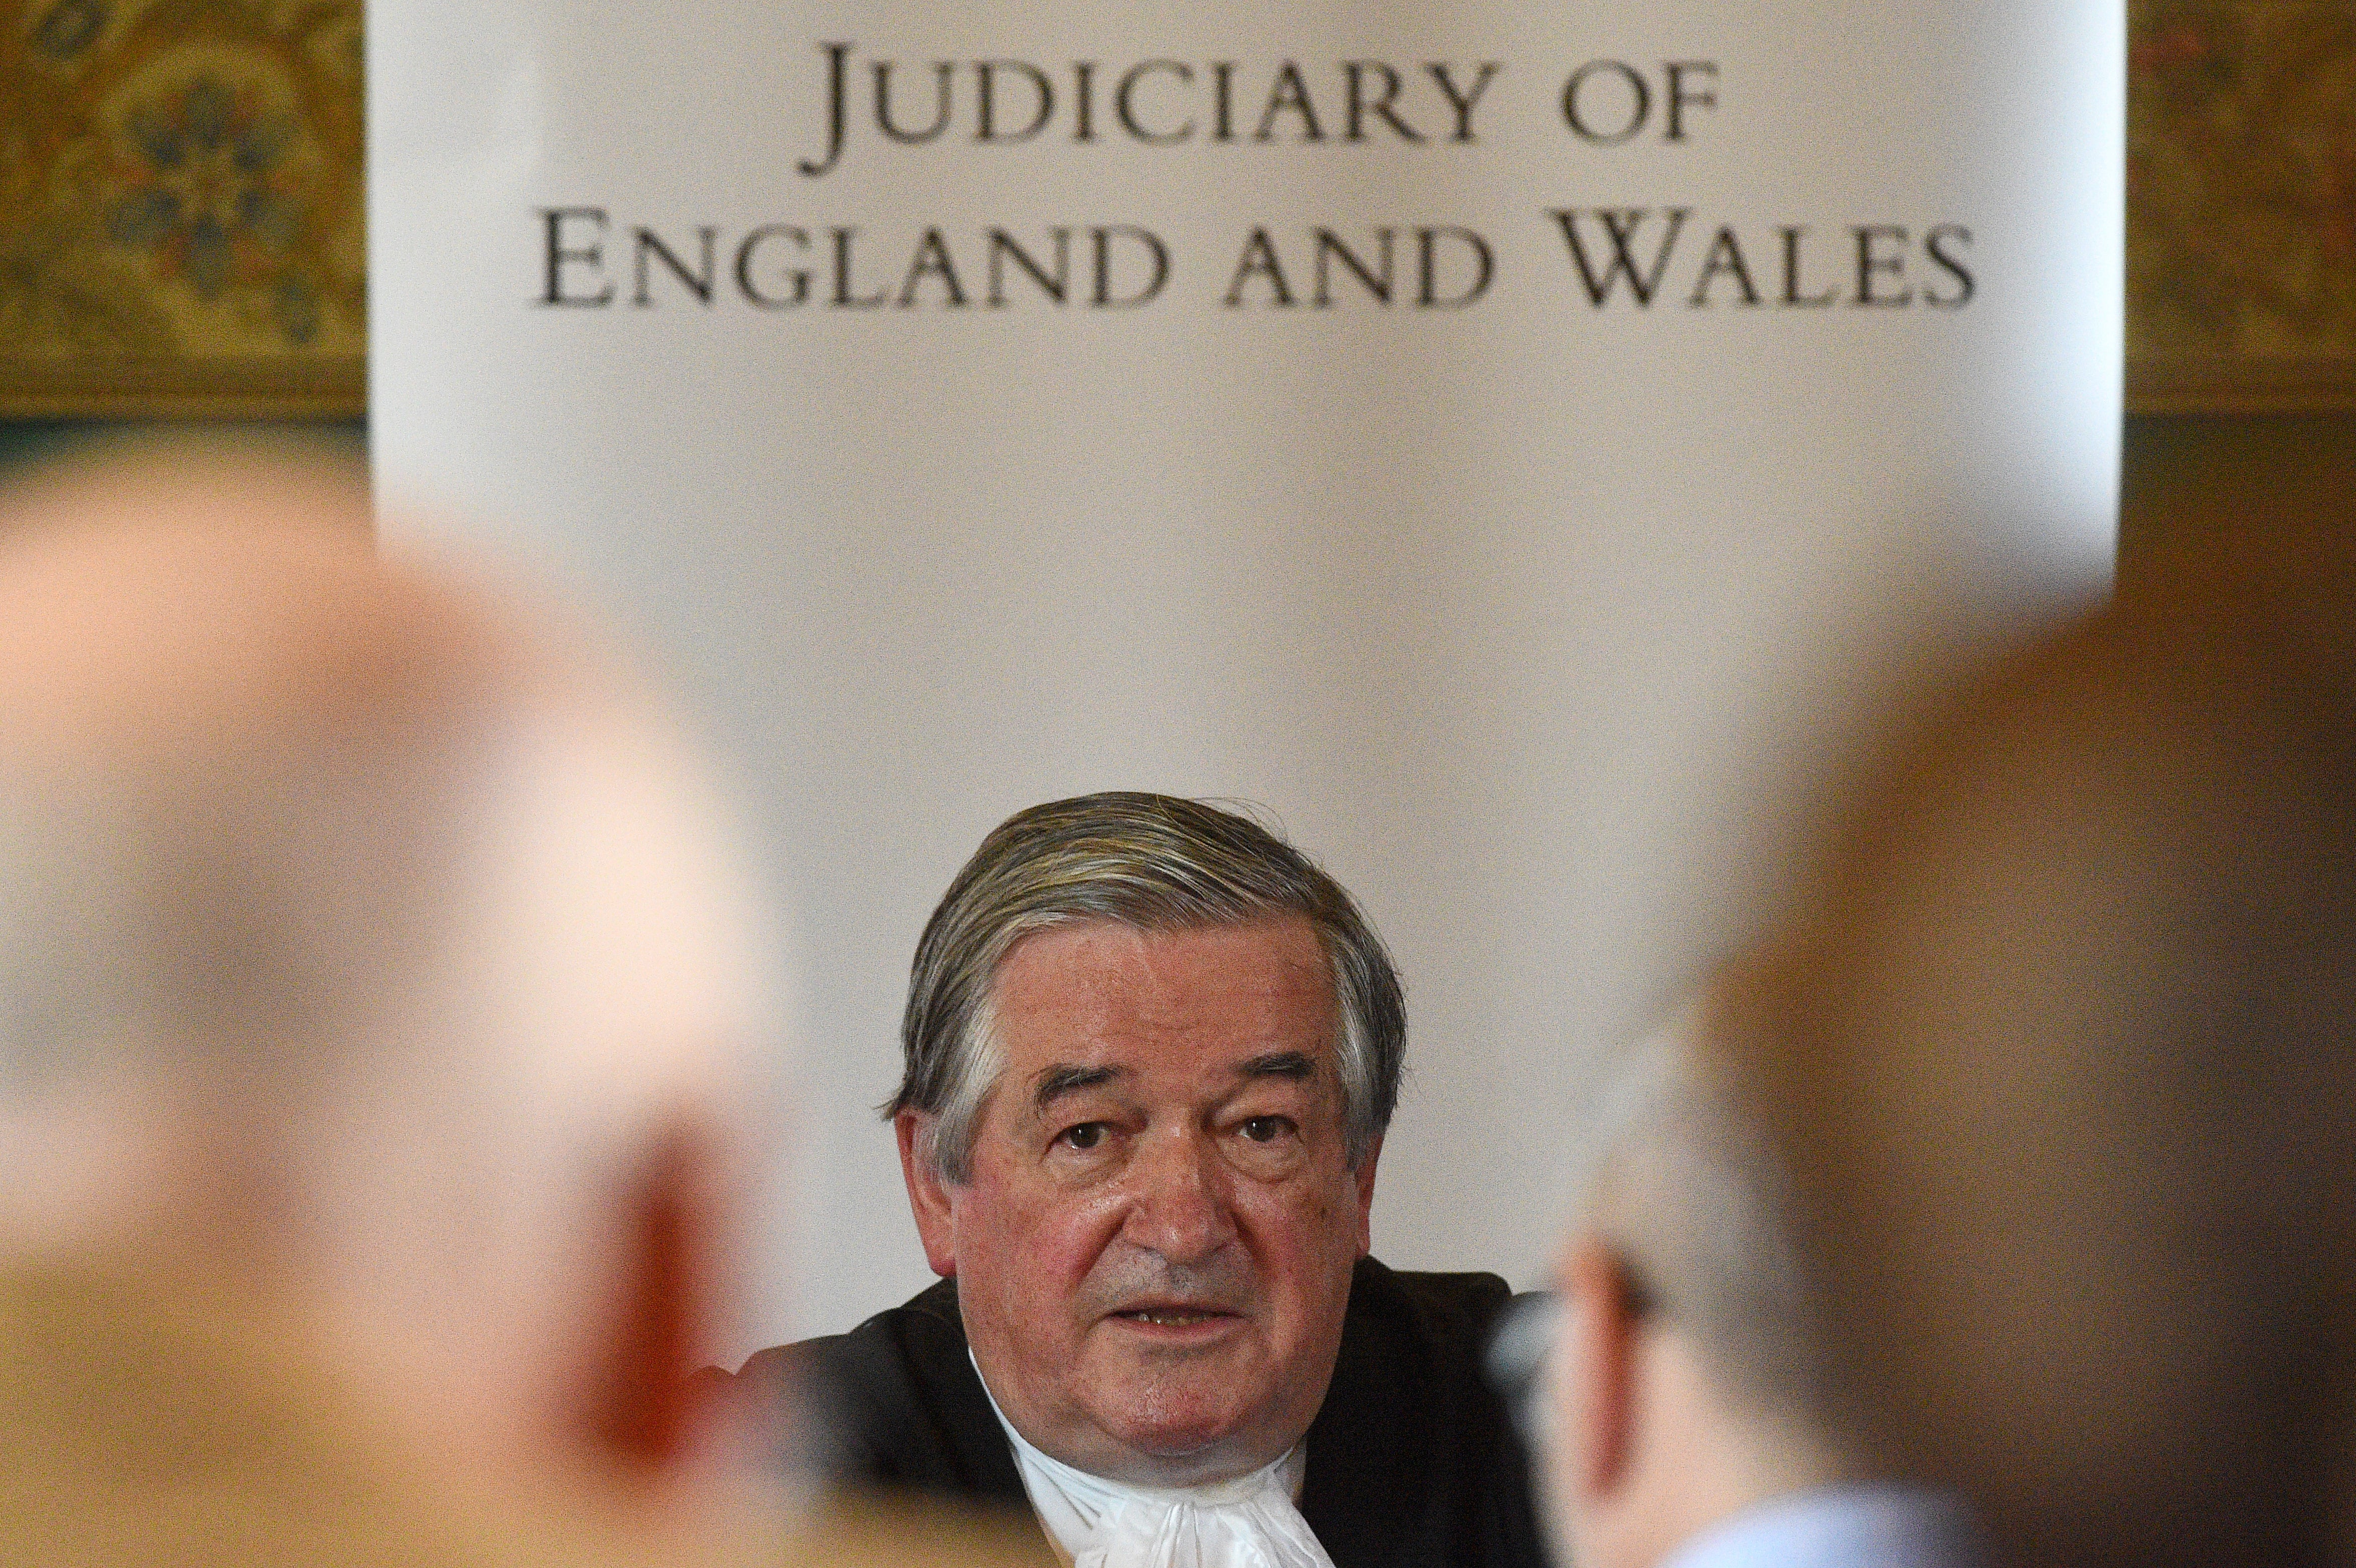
[368,0,2123,1349]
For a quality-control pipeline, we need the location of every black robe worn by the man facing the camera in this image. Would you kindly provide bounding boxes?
[735,1257,1545,1568]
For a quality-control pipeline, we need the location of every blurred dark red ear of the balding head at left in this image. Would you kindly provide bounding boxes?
[587,1123,726,1474]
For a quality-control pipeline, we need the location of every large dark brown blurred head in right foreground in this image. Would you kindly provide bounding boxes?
[1751,542,2356,1565]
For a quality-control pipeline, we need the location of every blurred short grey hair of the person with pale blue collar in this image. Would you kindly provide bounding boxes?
[1583,986,1826,1427]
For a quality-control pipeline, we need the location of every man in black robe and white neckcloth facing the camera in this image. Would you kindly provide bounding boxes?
[747,794,1538,1568]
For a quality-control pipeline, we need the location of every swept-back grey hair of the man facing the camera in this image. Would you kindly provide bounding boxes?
[883,791,1407,1182]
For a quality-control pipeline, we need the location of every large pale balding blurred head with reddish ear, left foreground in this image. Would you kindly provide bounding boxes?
[0,445,768,1549]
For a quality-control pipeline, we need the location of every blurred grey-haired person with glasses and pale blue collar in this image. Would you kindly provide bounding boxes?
[1534,970,1979,1568]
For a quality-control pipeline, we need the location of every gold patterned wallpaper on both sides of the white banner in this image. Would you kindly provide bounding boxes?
[0,0,2356,415]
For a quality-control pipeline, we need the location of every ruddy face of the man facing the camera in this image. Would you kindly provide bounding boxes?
[900,918,1374,1485]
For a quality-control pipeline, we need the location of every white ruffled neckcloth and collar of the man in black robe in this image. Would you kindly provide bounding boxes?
[966,1349,1333,1568]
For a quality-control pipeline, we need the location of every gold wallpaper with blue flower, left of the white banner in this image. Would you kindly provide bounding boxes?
[0,0,368,415]
